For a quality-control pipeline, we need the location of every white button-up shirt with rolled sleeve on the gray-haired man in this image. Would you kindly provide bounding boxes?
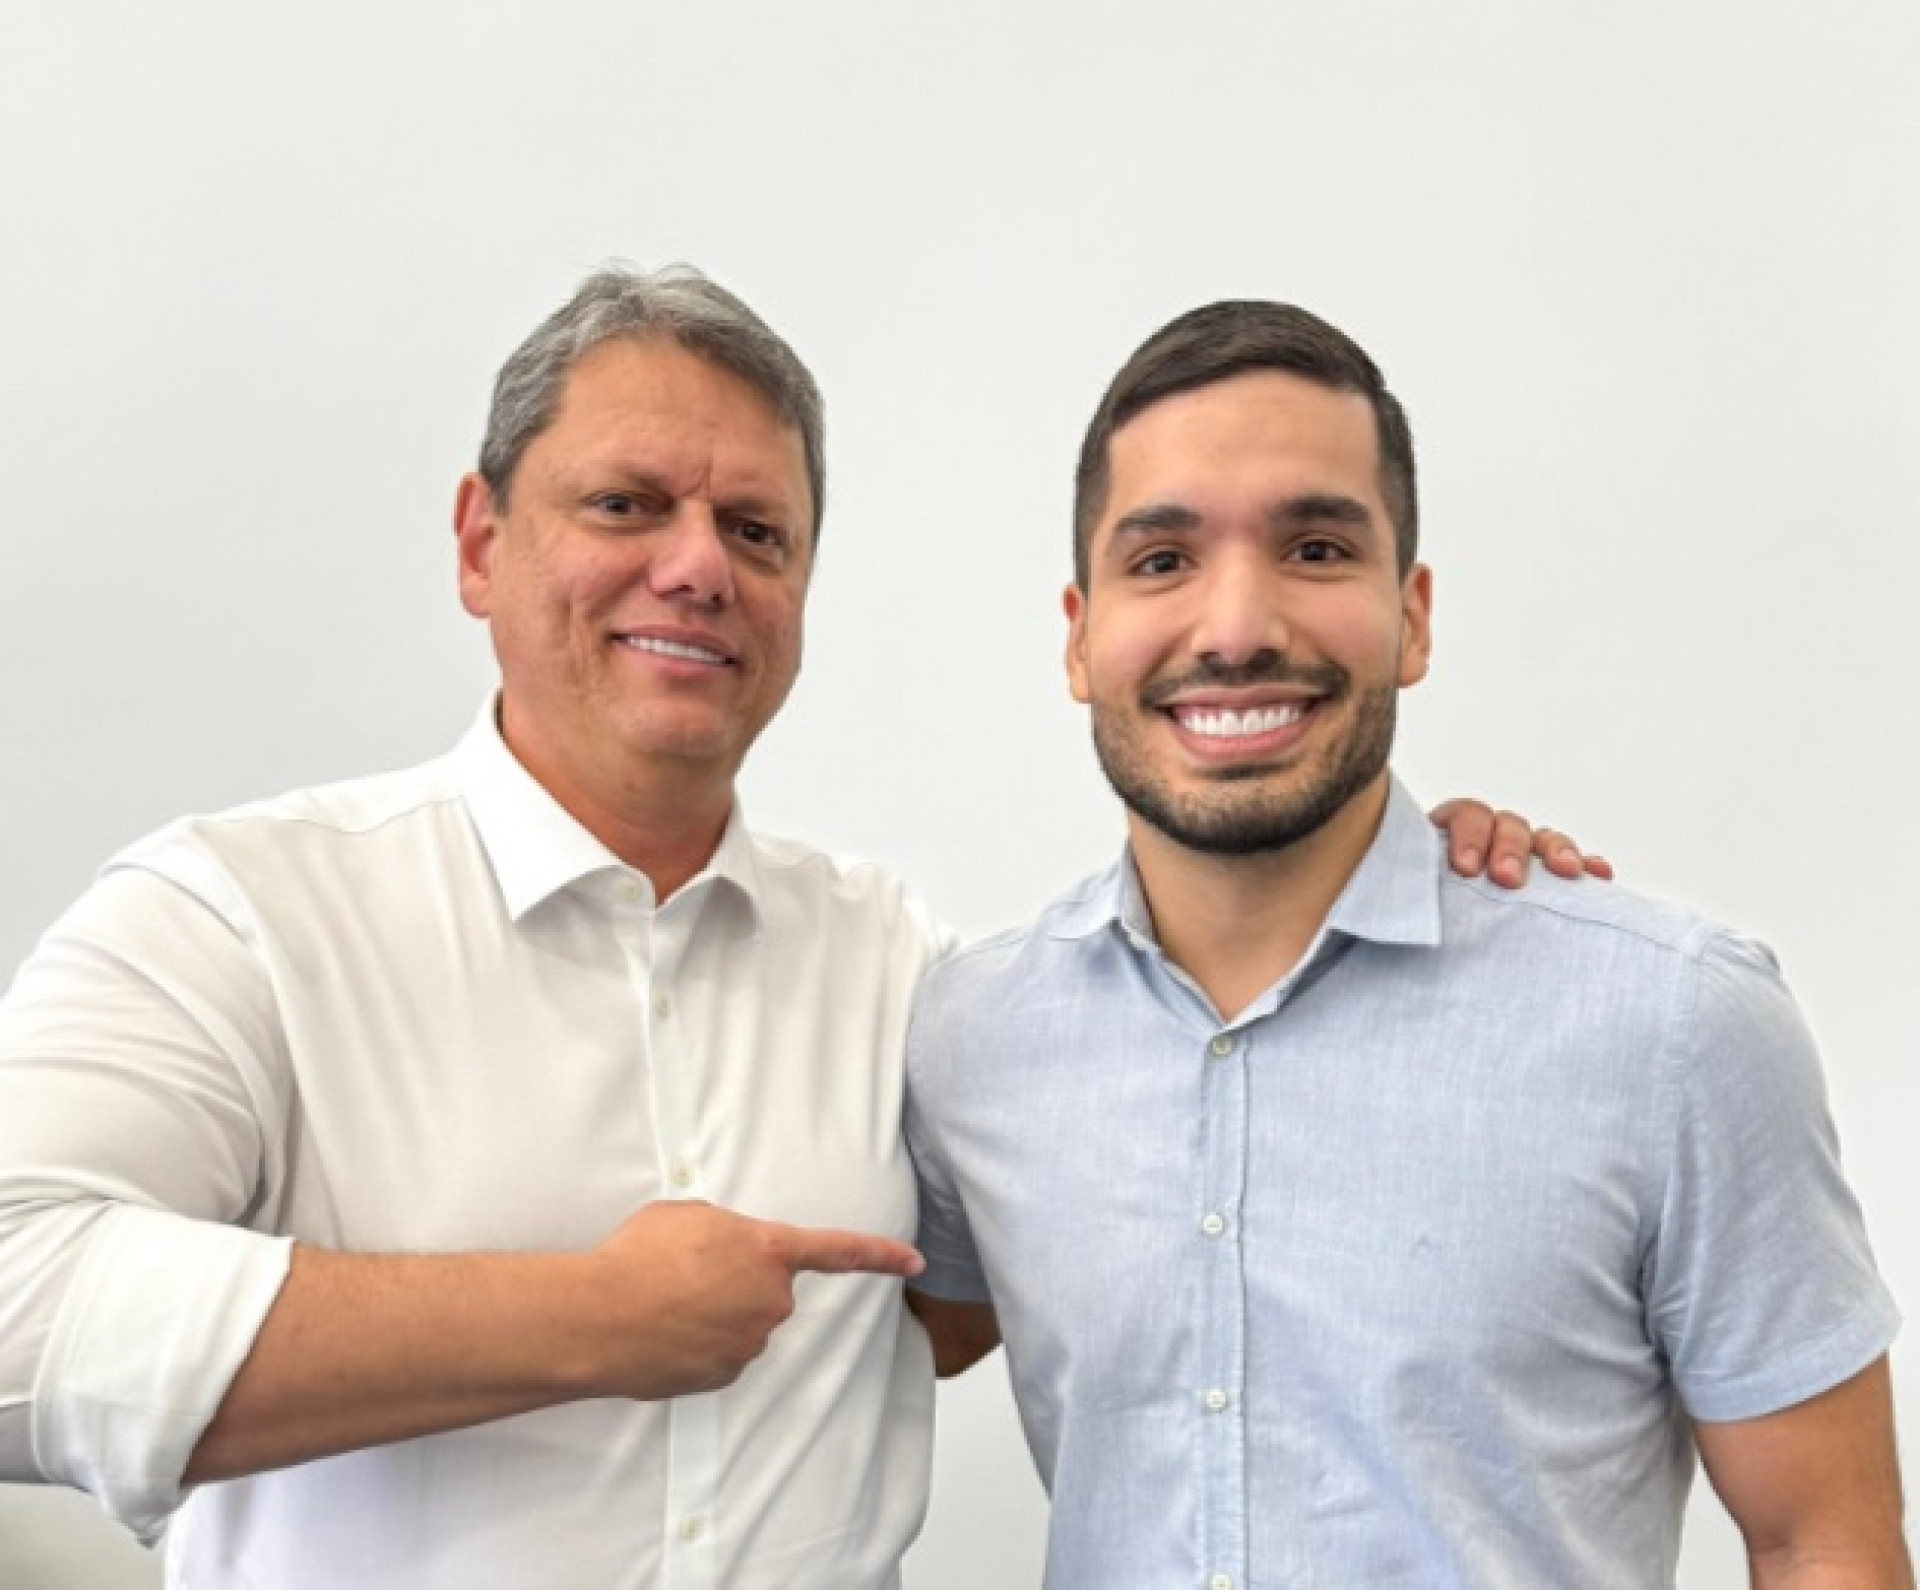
[0,714,941,1590]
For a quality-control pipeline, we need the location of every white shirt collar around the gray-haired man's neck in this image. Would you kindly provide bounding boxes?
[453,697,760,922]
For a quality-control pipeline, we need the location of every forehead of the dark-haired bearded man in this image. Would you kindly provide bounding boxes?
[1102,371,1384,522]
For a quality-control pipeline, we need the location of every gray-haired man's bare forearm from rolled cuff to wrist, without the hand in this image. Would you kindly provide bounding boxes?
[184,1246,599,1484]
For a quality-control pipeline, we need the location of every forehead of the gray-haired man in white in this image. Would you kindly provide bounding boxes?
[522,338,812,518]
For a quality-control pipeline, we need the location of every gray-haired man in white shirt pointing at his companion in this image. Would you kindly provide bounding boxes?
[0,271,1574,1590]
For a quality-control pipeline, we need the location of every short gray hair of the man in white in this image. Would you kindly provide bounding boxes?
[480,265,828,545]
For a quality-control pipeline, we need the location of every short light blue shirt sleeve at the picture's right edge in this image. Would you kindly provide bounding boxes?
[1645,933,1899,1421]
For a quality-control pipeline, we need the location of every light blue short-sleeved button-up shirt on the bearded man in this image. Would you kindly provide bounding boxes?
[908,785,1897,1590]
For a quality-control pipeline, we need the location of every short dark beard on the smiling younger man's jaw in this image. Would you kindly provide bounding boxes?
[1092,674,1400,856]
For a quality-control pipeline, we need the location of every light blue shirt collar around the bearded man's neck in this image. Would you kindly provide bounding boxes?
[1050,778,1442,945]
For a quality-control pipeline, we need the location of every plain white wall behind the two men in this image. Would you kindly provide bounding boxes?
[0,0,1920,1590]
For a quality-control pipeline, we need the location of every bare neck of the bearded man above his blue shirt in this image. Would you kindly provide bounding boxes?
[1127,772,1386,1020]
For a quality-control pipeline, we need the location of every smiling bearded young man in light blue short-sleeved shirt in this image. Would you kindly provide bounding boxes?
[908,303,1910,1590]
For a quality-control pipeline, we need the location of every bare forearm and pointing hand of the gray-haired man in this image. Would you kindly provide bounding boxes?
[186,1200,920,1484]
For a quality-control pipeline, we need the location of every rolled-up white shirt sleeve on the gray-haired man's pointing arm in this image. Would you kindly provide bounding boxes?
[0,856,290,1538]
